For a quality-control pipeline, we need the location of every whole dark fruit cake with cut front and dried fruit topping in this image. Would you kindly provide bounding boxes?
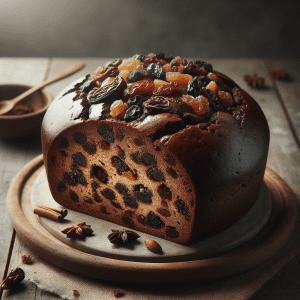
[42,53,269,244]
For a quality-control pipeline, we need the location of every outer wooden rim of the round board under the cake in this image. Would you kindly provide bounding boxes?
[8,155,297,284]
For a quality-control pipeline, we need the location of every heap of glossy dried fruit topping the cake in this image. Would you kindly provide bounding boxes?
[64,53,244,130]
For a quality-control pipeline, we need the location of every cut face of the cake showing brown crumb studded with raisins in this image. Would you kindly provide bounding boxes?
[45,120,196,244]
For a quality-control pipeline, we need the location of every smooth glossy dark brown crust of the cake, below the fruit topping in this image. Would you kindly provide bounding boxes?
[42,71,269,244]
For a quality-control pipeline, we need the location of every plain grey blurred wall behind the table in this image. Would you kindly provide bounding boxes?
[0,0,300,59]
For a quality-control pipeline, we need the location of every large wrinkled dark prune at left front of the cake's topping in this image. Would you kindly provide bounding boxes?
[88,76,127,104]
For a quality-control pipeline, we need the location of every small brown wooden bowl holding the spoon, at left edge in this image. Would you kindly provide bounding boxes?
[0,84,53,138]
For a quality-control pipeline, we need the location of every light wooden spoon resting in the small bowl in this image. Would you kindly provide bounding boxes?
[0,62,85,115]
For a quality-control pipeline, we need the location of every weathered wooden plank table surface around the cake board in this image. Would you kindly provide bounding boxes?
[0,58,300,300]
